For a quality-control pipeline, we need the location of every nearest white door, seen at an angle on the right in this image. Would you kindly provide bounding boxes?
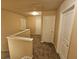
[60,9,74,59]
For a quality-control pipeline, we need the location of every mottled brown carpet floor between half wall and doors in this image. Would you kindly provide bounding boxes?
[33,36,60,59]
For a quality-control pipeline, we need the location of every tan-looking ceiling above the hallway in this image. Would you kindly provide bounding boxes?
[1,0,63,13]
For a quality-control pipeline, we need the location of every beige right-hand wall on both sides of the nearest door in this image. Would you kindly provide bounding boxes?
[54,0,77,59]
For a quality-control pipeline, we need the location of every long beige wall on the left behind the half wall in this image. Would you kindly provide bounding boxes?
[1,9,23,51]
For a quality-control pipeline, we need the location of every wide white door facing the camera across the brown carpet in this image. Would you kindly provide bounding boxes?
[42,16,55,43]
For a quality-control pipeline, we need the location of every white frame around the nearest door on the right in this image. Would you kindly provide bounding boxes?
[56,2,76,55]
